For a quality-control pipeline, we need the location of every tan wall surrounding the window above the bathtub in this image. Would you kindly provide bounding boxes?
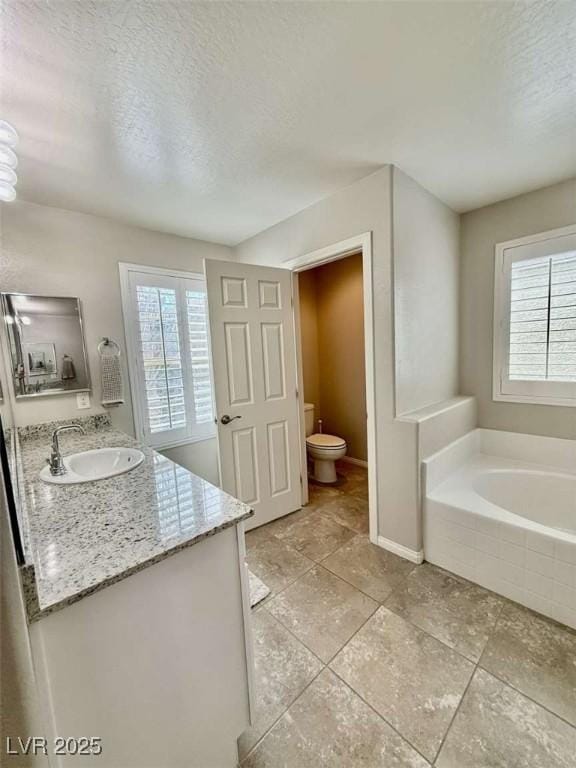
[460,179,576,438]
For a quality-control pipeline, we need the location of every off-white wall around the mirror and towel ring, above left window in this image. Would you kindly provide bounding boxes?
[0,201,234,468]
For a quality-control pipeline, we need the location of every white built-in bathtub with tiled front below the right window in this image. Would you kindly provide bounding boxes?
[422,429,576,629]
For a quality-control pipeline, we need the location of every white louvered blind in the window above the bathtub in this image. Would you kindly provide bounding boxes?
[508,251,576,382]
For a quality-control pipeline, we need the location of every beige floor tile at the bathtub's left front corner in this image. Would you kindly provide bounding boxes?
[386,563,504,661]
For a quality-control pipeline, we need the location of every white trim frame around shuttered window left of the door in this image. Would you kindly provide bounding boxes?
[118,262,216,450]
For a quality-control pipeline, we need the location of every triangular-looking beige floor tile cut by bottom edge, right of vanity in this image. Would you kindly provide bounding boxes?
[243,669,428,768]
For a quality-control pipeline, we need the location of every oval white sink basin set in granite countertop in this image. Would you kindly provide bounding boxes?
[40,448,144,485]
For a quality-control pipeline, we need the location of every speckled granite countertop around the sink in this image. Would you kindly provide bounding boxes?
[18,417,253,621]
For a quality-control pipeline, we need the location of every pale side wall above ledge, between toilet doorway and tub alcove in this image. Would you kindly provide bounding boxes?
[393,168,460,415]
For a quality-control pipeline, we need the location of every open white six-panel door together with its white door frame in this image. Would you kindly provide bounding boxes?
[205,233,378,544]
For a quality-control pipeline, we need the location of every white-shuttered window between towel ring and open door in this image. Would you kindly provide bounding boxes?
[120,264,216,448]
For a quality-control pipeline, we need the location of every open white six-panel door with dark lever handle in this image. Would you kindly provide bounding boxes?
[205,260,301,528]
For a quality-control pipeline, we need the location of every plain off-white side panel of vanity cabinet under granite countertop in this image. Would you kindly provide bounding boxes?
[30,522,252,768]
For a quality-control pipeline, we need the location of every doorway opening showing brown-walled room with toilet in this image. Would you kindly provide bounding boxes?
[297,253,368,486]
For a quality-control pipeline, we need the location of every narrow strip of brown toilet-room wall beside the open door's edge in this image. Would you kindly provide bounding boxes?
[298,269,321,418]
